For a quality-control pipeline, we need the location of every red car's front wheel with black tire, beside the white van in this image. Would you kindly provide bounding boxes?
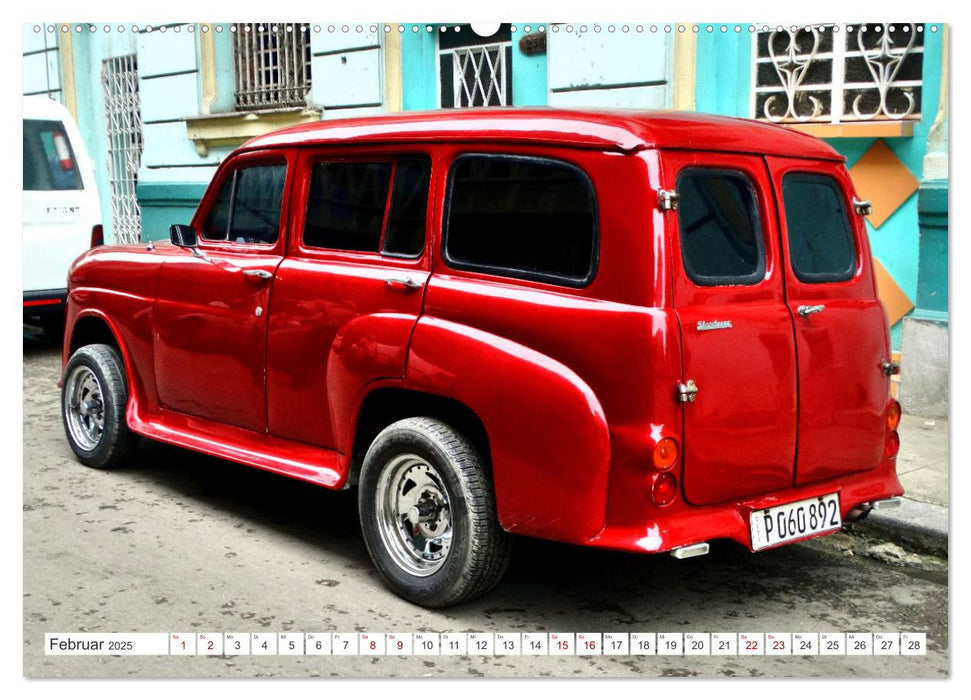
[61,345,138,469]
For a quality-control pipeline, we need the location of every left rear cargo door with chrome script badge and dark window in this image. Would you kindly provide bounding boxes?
[662,151,796,505]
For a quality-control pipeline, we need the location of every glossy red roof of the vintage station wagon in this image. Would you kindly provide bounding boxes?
[241,107,844,160]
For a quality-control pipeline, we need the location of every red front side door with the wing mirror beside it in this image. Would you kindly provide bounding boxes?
[154,150,293,432]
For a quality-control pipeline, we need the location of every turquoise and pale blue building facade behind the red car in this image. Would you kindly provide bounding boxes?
[23,23,949,415]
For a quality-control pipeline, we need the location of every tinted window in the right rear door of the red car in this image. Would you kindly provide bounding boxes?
[782,173,856,283]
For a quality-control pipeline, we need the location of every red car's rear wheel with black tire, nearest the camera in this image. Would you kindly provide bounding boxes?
[358,418,511,608]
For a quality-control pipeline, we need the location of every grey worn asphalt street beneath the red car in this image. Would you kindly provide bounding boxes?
[23,334,949,678]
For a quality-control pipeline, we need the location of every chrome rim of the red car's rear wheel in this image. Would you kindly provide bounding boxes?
[375,454,452,576]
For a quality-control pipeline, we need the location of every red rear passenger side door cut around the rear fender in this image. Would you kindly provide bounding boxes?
[266,148,434,449]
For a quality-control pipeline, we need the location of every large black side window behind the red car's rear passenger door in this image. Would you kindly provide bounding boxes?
[443,155,597,287]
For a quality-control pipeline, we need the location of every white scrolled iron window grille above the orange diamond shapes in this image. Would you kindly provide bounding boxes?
[752,24,924,123]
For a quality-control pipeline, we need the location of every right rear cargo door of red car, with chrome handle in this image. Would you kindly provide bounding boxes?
[766,158,890,484]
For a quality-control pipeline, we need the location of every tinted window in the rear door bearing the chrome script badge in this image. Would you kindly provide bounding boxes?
[677,169,765,286]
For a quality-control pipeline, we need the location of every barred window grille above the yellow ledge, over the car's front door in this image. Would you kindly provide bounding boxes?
[233,22,310,110]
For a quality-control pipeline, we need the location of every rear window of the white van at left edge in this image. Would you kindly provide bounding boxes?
[24,119,82,192]
